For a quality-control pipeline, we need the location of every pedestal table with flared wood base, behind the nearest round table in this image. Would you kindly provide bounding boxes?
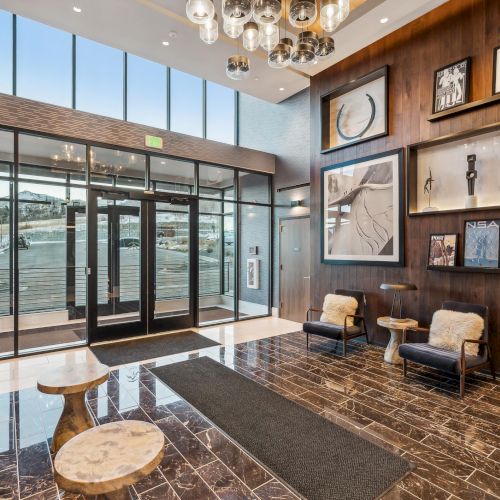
[37,363,109,453]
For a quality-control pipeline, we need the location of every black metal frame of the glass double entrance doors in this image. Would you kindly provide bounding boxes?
[87,187,198,344]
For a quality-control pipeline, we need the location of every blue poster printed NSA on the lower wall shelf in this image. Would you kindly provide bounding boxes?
[464,219,500,268]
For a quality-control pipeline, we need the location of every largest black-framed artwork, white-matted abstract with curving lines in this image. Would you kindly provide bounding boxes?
[321,149,404,266]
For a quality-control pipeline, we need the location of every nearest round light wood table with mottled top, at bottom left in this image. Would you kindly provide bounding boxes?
[54,420,165,500]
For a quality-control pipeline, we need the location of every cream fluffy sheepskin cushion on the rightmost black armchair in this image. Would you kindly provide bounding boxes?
[429,309,484,356]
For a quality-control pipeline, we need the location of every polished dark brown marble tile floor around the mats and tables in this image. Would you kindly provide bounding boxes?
[0,318,500,500]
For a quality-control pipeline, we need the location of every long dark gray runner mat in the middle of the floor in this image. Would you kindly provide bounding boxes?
[151,357,412,500]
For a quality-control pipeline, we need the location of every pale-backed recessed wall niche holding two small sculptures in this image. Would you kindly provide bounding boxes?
[406,122,500,217]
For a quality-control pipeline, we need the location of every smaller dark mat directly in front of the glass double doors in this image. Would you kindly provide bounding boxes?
[90,330,220,366]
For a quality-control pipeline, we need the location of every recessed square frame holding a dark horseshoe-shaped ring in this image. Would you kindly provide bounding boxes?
[321,66,389,153]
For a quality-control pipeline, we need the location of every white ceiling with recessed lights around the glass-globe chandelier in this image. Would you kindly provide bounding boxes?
[0,0,447,103]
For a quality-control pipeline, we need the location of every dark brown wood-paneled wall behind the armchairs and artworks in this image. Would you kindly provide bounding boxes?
[311,0,500,362]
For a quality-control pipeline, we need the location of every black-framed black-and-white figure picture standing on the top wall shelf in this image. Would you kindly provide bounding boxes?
[432,57,471,113]
